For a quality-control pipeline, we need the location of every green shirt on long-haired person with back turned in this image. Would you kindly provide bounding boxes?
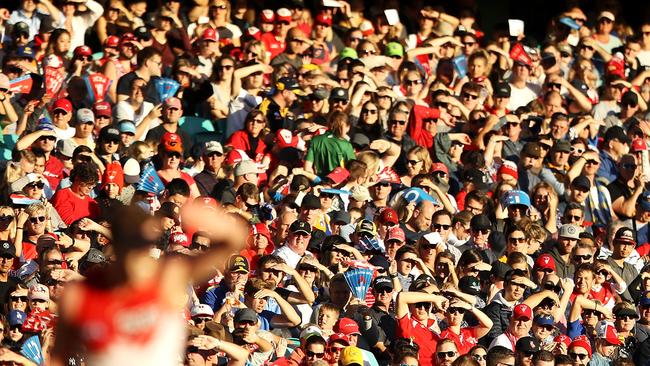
[306,132,354,175]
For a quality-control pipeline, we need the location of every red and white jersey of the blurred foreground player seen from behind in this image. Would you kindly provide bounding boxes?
[72,283,186,366]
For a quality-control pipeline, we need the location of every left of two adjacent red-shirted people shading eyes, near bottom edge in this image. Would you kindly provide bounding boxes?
[395,288,448,365]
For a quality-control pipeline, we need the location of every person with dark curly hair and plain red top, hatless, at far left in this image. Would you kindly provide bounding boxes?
[52,163,99,225]
